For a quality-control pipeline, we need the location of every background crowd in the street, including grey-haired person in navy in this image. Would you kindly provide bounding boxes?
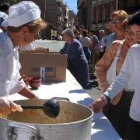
[60,21,116,89]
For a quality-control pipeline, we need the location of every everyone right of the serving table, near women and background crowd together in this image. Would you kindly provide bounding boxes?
[61,10,140,140]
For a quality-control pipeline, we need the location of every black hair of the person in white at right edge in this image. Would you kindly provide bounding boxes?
[128,11,140,26]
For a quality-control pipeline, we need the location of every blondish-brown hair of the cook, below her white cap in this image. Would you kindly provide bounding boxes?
[7,18,47,32]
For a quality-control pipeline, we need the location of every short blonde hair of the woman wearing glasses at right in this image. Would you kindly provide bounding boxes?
[111,10,129,20]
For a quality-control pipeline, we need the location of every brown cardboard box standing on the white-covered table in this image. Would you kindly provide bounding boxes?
[19,51,67,82]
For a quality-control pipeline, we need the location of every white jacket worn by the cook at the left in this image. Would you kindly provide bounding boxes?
[0,32,25,97]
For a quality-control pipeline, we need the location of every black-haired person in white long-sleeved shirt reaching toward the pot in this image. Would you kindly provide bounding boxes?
[91,11,140,140]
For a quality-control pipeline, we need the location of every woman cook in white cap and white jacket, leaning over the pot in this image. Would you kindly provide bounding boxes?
[0,1,46,114]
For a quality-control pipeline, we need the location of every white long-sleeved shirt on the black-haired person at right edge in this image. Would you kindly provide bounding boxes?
[104,44,140,122]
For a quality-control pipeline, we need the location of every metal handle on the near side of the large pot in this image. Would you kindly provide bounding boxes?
[7,122,39,140]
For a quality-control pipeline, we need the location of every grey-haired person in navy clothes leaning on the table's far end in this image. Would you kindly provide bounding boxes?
[60,29,90,88]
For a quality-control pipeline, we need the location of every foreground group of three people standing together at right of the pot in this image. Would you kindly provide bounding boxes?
[91,11,140,140]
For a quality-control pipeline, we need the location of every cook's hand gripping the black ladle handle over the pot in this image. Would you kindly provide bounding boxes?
[0,97,23,114]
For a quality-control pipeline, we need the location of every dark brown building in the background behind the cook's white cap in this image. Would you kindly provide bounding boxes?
[15,0,76,39]
